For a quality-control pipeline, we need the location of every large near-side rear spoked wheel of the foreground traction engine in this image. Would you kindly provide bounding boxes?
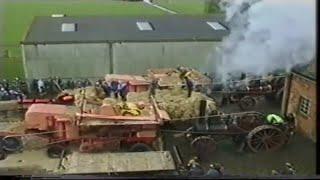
[247,125,286,152]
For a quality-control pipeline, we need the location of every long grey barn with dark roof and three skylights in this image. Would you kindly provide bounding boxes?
[21,15,229,79]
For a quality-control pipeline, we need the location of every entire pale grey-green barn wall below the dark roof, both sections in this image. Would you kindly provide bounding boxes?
[22,42,219,79]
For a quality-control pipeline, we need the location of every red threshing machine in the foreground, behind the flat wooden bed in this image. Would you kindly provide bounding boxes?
[7,100,163,152]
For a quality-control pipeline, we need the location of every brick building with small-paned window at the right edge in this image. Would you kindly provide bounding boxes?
[282,59,317,142]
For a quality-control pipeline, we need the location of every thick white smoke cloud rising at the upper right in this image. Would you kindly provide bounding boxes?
[214,0,316,79]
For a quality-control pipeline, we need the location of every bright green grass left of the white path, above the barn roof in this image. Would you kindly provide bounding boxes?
[2,0,165,44]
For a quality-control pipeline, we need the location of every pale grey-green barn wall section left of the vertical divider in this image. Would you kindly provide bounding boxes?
[23,43,110,79]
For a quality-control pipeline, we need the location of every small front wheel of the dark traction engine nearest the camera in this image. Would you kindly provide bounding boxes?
[191,136,216,161]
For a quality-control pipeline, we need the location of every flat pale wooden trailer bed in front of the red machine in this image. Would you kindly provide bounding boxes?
[60,151,175,174]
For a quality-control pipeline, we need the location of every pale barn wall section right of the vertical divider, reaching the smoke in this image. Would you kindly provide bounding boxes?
[113,42,219,74]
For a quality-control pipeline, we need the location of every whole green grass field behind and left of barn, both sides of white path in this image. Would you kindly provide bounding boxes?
[0,0,220,79]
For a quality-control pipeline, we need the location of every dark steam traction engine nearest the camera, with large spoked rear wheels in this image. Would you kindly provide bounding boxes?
[162,101,295,160]
